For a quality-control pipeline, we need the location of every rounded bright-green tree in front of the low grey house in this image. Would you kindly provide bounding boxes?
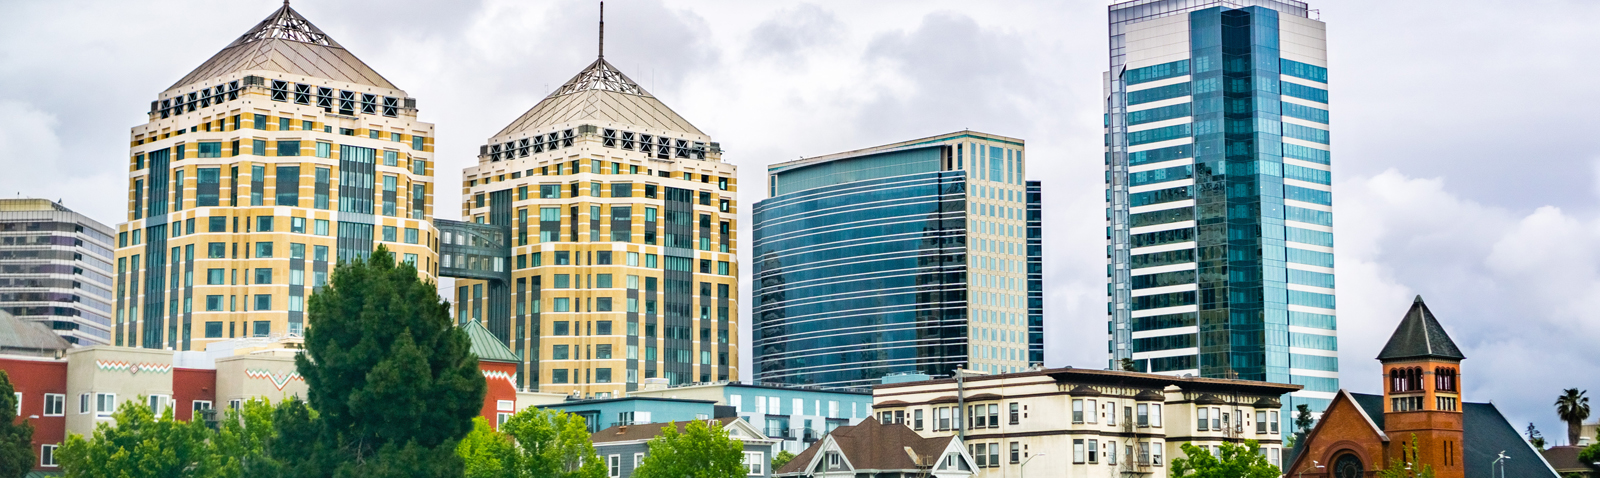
[634,420,746,478]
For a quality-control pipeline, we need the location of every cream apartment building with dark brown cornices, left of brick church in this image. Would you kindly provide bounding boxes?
[872,368,1301,478]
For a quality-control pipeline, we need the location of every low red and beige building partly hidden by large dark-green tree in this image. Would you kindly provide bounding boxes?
[0,312,550,472]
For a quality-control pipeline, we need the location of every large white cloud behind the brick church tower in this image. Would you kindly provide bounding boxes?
[1334,169,1600,447]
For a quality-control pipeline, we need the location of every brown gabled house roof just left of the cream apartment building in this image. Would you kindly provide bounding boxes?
[773,417,955,475]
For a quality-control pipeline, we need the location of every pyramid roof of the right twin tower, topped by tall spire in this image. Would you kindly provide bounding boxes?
[494,58,706,137]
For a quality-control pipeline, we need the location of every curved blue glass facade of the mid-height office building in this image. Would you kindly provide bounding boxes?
[752,171,968,388]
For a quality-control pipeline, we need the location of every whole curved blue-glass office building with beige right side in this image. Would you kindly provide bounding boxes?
[752,131,1043,388]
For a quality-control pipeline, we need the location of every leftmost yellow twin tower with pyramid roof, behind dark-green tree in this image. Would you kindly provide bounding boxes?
[114,5,437,350]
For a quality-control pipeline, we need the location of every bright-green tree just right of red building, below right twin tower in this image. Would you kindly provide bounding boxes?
[501,408,604,478]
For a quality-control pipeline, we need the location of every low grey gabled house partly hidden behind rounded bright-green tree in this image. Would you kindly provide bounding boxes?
[589,417,778,478]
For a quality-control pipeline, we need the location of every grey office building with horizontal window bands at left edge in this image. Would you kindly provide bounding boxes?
[0,198,115,345]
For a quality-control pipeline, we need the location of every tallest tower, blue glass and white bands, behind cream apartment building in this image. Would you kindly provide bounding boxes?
[1106,0,1339,411]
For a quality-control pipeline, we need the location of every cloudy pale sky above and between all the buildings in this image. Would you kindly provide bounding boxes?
[0,0,1600,443]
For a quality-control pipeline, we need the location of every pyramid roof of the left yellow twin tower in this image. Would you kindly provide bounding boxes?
[168,2,400,90]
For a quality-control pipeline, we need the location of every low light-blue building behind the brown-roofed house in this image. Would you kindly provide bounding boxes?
[632,382,872,454]
